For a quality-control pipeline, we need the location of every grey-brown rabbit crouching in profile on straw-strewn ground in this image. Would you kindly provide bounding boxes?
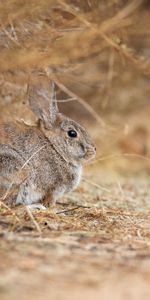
[0,80,96,209]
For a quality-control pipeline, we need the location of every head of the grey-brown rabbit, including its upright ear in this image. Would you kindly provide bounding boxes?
[28,78,96,163]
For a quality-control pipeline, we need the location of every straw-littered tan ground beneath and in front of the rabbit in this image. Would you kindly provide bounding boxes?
[0,173,150,300]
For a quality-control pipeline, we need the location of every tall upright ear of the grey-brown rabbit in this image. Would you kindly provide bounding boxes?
[28,81,58,129]
